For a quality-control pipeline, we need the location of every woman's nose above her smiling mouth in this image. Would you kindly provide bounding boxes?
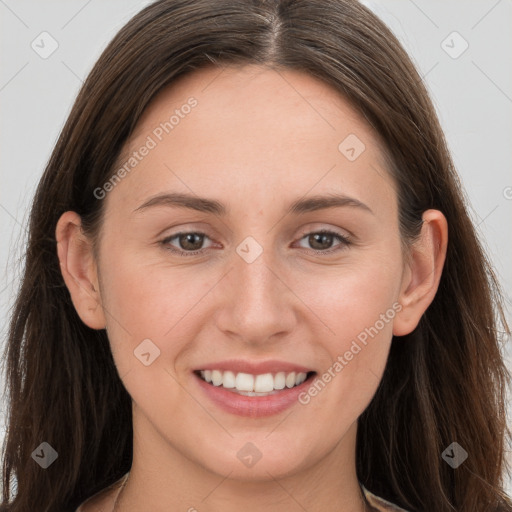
[216,241,298,345]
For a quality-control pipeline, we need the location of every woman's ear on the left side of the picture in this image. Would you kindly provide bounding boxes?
[55,211,106,329]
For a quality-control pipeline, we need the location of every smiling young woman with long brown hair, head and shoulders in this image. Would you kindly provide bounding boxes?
[0,0,512,512]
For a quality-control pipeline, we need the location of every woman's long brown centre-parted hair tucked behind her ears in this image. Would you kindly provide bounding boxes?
[0,0,512,512]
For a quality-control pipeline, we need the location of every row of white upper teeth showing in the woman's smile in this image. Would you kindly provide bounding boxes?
[200,370,307,396]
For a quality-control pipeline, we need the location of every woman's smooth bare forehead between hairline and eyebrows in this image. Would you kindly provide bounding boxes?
[105,66,393,217]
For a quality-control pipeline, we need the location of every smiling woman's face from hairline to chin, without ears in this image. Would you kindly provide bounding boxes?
[86,66,408,479]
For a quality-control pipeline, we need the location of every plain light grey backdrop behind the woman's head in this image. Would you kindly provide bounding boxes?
[0,0,512,493]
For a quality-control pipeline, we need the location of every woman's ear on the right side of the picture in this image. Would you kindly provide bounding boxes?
[393,210,448,336]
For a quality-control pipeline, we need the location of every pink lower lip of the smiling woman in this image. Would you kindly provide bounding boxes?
[193,373,314,418]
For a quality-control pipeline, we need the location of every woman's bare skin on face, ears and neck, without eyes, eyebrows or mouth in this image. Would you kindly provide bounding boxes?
[56,66,447,512]
